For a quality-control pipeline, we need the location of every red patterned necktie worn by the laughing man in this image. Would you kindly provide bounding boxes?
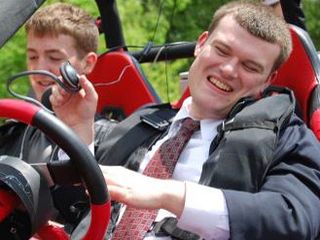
[112,118,200,240]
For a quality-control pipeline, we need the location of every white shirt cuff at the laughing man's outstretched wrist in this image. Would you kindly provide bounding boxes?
[177,182,230,240]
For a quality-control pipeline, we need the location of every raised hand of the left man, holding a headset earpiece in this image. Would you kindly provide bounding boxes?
[50,75,98,144]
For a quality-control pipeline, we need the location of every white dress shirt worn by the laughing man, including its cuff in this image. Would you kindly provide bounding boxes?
[139,97,230,240]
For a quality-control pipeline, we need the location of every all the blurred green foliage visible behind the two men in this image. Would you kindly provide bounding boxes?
[0,0,320,101]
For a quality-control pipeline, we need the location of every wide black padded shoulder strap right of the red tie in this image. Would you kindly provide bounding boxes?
[200,88,295,192]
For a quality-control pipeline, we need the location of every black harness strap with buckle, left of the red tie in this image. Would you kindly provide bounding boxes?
[98,104,176,165]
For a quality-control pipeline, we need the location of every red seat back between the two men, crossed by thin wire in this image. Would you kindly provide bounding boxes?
[88,51,161,120]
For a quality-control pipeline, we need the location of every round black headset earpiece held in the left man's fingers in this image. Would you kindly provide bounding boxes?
[60,61,81,92]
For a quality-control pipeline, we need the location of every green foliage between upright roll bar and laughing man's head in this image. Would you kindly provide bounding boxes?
[118,0,227,101]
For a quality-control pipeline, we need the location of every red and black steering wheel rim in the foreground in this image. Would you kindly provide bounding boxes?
[0,99,110,240]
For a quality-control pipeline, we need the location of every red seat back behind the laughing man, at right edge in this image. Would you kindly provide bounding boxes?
[273,25,320,140]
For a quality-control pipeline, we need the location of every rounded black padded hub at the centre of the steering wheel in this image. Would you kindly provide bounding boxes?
[0,156,54,237]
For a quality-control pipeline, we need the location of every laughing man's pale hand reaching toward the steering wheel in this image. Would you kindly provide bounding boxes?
[100,166,185,217]
